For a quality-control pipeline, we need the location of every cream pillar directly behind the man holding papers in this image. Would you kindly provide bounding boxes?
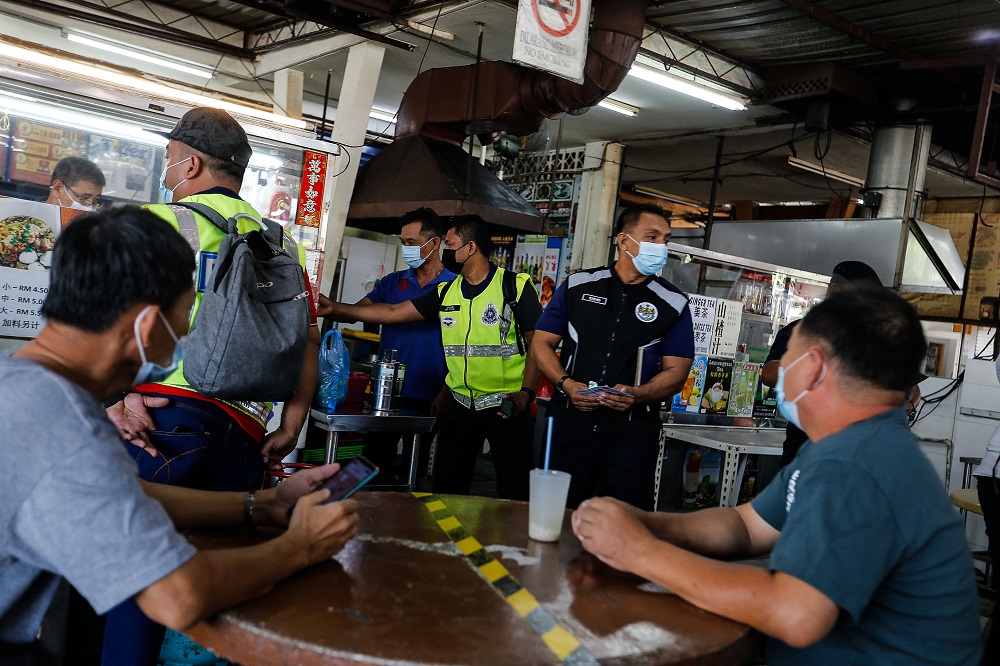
[570,142,625,270]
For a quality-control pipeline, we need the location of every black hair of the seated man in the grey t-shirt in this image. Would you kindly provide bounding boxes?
[41,206,195,333]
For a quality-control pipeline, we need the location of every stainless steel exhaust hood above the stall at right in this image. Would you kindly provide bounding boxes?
[708,218,965,294]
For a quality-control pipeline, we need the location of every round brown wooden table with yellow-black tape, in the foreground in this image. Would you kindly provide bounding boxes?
[186,492,752,666]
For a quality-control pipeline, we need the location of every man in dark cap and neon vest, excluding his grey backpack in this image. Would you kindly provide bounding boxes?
[105,107,319,663]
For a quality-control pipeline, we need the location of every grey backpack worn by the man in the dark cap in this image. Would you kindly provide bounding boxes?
[170,202,309,402]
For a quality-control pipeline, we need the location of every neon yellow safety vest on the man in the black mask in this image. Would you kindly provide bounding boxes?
[438,268,528,409]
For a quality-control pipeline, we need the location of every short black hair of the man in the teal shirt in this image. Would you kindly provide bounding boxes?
[798,284,927,391]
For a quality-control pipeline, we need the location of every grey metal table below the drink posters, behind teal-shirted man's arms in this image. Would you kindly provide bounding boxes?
[663,423,785,506]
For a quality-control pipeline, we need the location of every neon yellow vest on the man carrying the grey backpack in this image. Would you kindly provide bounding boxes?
[145,194,306,427]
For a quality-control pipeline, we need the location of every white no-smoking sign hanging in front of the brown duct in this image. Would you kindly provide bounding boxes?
[513,0,590,83]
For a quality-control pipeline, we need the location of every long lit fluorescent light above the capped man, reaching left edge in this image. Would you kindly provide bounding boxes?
[0,41,309,130]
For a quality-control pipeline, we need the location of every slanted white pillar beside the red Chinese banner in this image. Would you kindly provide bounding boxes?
[320,42,385,294]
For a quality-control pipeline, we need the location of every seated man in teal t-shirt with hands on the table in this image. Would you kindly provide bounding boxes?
[573,288,980,666]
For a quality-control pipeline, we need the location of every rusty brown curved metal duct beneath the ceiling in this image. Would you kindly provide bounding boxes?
[396,0,646,145]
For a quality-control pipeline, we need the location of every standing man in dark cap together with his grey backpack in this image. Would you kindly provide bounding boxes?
[104,108,320,664]
